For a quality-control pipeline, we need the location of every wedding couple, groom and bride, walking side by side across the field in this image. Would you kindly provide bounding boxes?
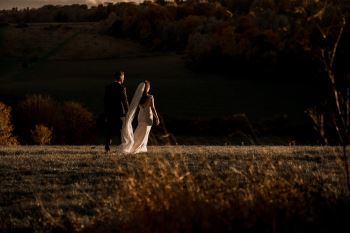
[104,71,160,154]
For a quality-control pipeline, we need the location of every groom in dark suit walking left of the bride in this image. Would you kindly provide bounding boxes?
[104,71,129,152]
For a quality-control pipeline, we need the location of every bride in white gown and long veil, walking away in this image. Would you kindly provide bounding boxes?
[120,80,160,154]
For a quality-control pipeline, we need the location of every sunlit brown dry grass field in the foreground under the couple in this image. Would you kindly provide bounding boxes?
[0,145,350,232]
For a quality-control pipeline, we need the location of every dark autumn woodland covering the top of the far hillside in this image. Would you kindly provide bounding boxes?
[0,0,350,79]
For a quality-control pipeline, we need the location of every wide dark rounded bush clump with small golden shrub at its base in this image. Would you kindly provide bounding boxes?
[16,95,95,145]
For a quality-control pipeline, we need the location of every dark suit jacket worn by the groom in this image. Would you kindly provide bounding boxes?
[104,82,129,118]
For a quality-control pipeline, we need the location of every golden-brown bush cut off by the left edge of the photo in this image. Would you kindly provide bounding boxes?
[0,102,17,145]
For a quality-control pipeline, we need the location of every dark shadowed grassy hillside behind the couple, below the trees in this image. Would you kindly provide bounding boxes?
[0,24,320,120]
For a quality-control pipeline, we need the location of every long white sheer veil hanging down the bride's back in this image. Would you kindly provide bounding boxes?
[120,82,146,153]
